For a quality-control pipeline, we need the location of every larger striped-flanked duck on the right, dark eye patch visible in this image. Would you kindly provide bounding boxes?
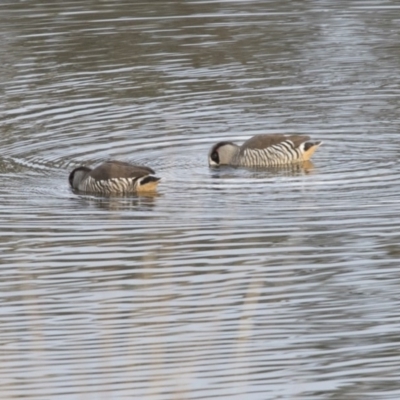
[208,135,321,167]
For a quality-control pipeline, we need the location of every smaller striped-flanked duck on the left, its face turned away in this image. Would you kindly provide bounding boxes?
[69,161,160,195]
